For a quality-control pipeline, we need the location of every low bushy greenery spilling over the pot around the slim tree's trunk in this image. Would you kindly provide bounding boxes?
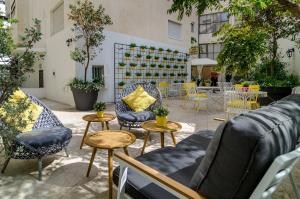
[68,78,104,92]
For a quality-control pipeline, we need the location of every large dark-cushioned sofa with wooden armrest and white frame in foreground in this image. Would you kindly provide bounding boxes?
[114,95,300,199]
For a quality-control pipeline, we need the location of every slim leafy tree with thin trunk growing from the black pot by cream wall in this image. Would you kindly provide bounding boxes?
[67,0,112,82]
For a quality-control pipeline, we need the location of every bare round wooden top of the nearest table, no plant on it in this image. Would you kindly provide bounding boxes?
[84,130,136,149]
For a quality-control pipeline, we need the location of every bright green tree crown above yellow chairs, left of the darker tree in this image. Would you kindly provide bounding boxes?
[217,25,268,75]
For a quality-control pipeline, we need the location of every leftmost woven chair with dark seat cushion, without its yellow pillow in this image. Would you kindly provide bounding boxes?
[0,94,72,180]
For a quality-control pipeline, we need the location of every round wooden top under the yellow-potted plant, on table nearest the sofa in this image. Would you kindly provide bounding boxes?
[141,120,182,133]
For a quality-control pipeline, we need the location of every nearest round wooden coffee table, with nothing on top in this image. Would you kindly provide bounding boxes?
[84,130,136,199]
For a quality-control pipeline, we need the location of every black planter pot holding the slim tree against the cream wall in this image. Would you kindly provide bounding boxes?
[71,88,99,111]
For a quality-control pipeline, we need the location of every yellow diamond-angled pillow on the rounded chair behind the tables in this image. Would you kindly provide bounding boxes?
[122,86,156,112]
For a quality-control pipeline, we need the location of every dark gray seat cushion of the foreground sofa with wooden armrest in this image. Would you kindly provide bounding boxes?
[113,132,212,199]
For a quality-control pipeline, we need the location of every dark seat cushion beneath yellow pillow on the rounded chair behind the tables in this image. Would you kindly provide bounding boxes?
[117,111,155,122]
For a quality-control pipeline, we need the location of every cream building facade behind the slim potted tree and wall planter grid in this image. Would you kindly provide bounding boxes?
[6,0,198,105]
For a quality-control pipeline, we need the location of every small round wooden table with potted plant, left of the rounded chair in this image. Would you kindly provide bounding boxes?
[80,113,116,149]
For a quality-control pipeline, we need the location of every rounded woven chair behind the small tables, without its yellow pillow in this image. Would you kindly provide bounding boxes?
[116,83,162,130]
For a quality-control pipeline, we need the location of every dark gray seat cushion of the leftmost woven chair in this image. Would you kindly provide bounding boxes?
[16,127,72,155]
